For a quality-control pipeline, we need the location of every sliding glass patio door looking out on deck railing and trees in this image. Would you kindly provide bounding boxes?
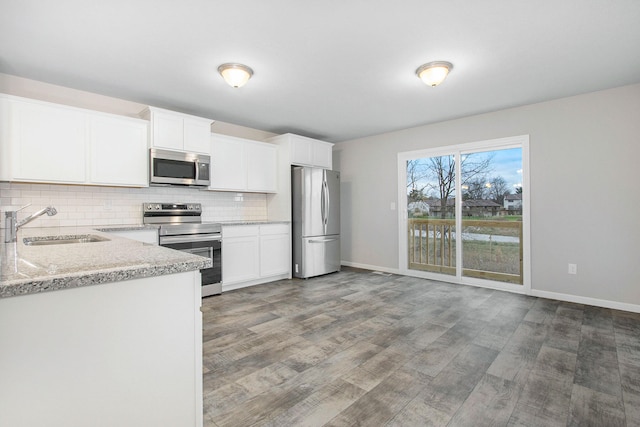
[398,136,529,287]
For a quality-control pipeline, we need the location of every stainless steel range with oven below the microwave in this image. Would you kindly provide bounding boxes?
[142,203,222,297]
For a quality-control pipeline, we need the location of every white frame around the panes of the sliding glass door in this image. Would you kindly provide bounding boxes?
[398,135,531,295]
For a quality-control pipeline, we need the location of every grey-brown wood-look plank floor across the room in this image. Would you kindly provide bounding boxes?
[203,269,640,427]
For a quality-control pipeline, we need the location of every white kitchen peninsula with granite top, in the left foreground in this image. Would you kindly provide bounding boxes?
[0,227,210,426]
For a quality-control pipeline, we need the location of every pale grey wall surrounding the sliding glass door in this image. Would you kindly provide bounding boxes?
[334,84,640,311]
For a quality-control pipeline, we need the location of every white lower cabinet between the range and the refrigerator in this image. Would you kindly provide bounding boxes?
[222,224,291,291]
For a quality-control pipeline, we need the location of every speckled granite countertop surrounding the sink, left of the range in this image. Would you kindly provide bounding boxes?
[0,226,211,298]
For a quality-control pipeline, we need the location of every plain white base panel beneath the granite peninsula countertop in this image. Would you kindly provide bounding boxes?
[0,271,203,427]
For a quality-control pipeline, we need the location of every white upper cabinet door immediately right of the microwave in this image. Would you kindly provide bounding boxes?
[209,135,247,191]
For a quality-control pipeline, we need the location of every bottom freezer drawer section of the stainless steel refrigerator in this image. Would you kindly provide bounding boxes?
[293,235,340,278]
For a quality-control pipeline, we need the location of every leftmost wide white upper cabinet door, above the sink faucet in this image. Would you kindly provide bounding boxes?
[9,101,86,183]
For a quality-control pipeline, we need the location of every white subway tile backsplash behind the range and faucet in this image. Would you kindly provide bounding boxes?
[0,182,267,227]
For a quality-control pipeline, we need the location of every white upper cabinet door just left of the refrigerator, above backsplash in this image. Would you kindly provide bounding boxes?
[245,142,278,193]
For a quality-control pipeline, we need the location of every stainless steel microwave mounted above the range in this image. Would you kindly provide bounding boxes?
[149,148,211,187]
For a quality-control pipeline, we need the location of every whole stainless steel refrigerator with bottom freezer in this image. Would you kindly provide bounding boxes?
[291,166,340,278]
